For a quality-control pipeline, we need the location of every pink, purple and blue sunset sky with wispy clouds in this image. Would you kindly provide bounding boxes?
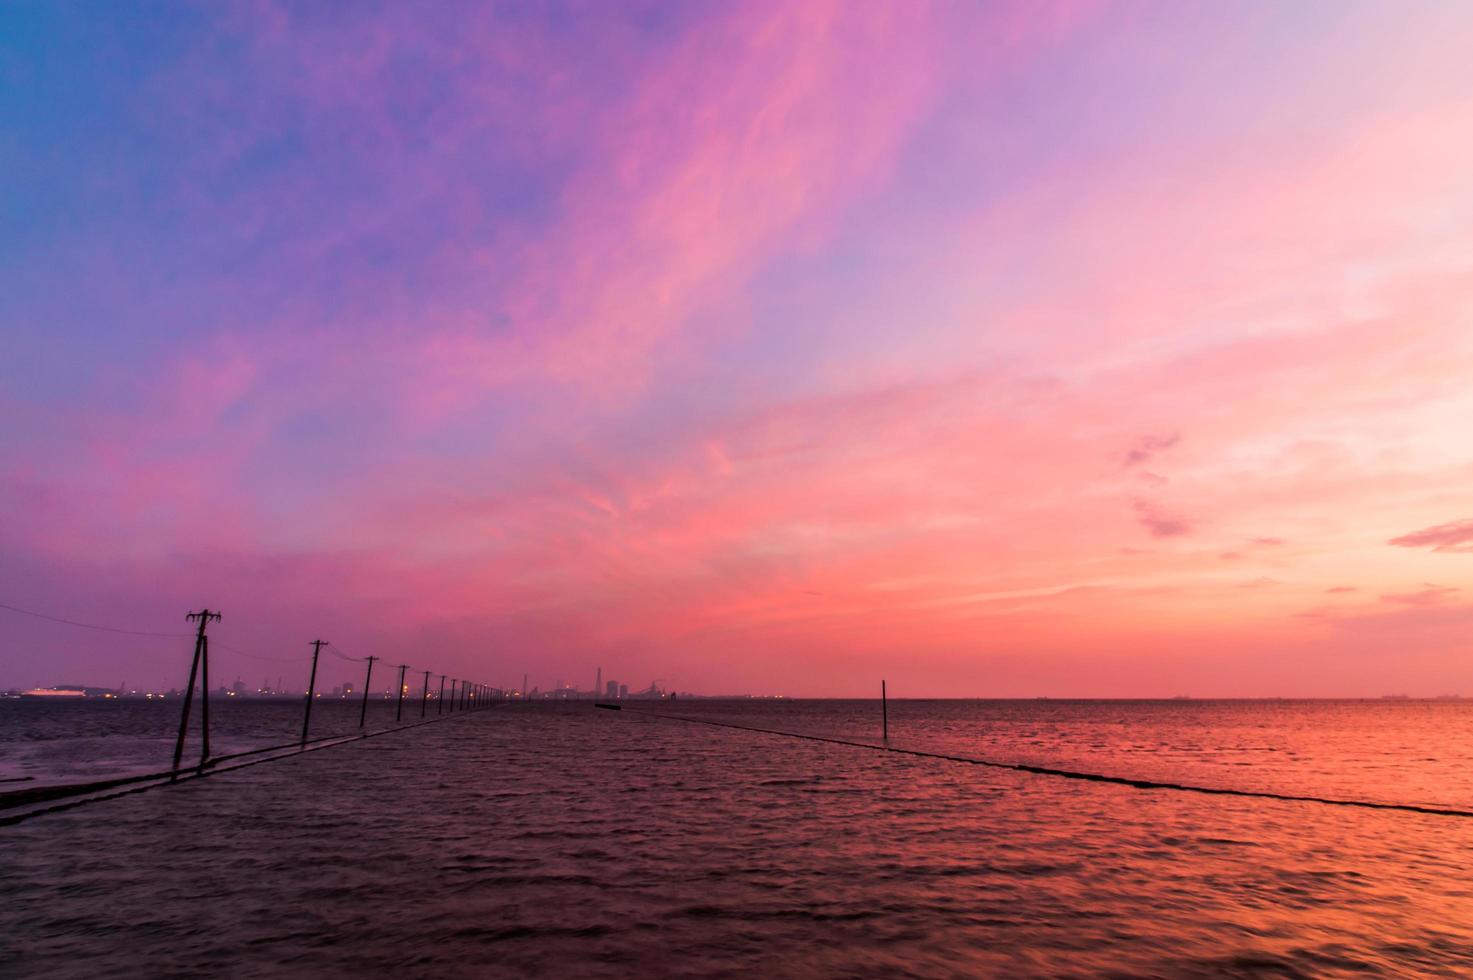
[0,0,1473,697]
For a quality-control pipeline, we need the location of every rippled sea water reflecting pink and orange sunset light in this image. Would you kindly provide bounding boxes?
[0,701,1473,977]
